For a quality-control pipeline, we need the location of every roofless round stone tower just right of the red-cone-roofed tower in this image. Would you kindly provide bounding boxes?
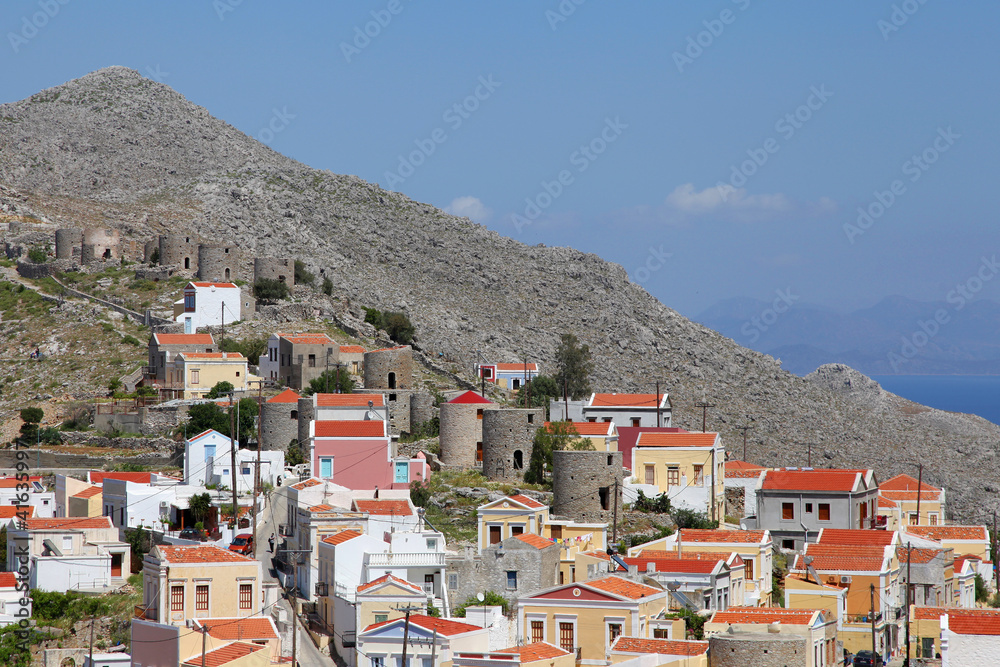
[483,408,545,482]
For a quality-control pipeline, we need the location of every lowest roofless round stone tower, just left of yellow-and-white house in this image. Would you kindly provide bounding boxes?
[552,449,624,523]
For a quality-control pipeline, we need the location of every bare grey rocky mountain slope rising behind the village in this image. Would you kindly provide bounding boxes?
[0,67,1000,521]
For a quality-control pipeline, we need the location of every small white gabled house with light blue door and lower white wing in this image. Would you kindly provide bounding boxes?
[184,429,285,493]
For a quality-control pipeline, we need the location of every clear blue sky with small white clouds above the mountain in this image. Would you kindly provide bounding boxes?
[0,0,1000,316]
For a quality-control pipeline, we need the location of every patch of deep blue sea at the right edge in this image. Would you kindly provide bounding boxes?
[872,375,1000,424]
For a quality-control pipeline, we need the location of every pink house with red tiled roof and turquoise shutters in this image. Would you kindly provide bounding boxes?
[309,419,430,489]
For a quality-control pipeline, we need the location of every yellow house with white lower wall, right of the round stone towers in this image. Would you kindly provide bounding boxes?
[632,432,726,521]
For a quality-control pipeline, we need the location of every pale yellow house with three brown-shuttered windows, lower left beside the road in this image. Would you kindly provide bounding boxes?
[142,544,263,625]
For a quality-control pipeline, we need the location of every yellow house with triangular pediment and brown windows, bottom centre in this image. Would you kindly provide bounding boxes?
[517,576,669,665]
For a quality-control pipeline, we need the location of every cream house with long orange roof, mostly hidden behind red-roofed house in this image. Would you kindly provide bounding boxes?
[628,528,773,607]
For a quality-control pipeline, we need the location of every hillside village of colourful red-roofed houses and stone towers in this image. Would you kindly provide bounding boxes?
[0,222,1000,667]
